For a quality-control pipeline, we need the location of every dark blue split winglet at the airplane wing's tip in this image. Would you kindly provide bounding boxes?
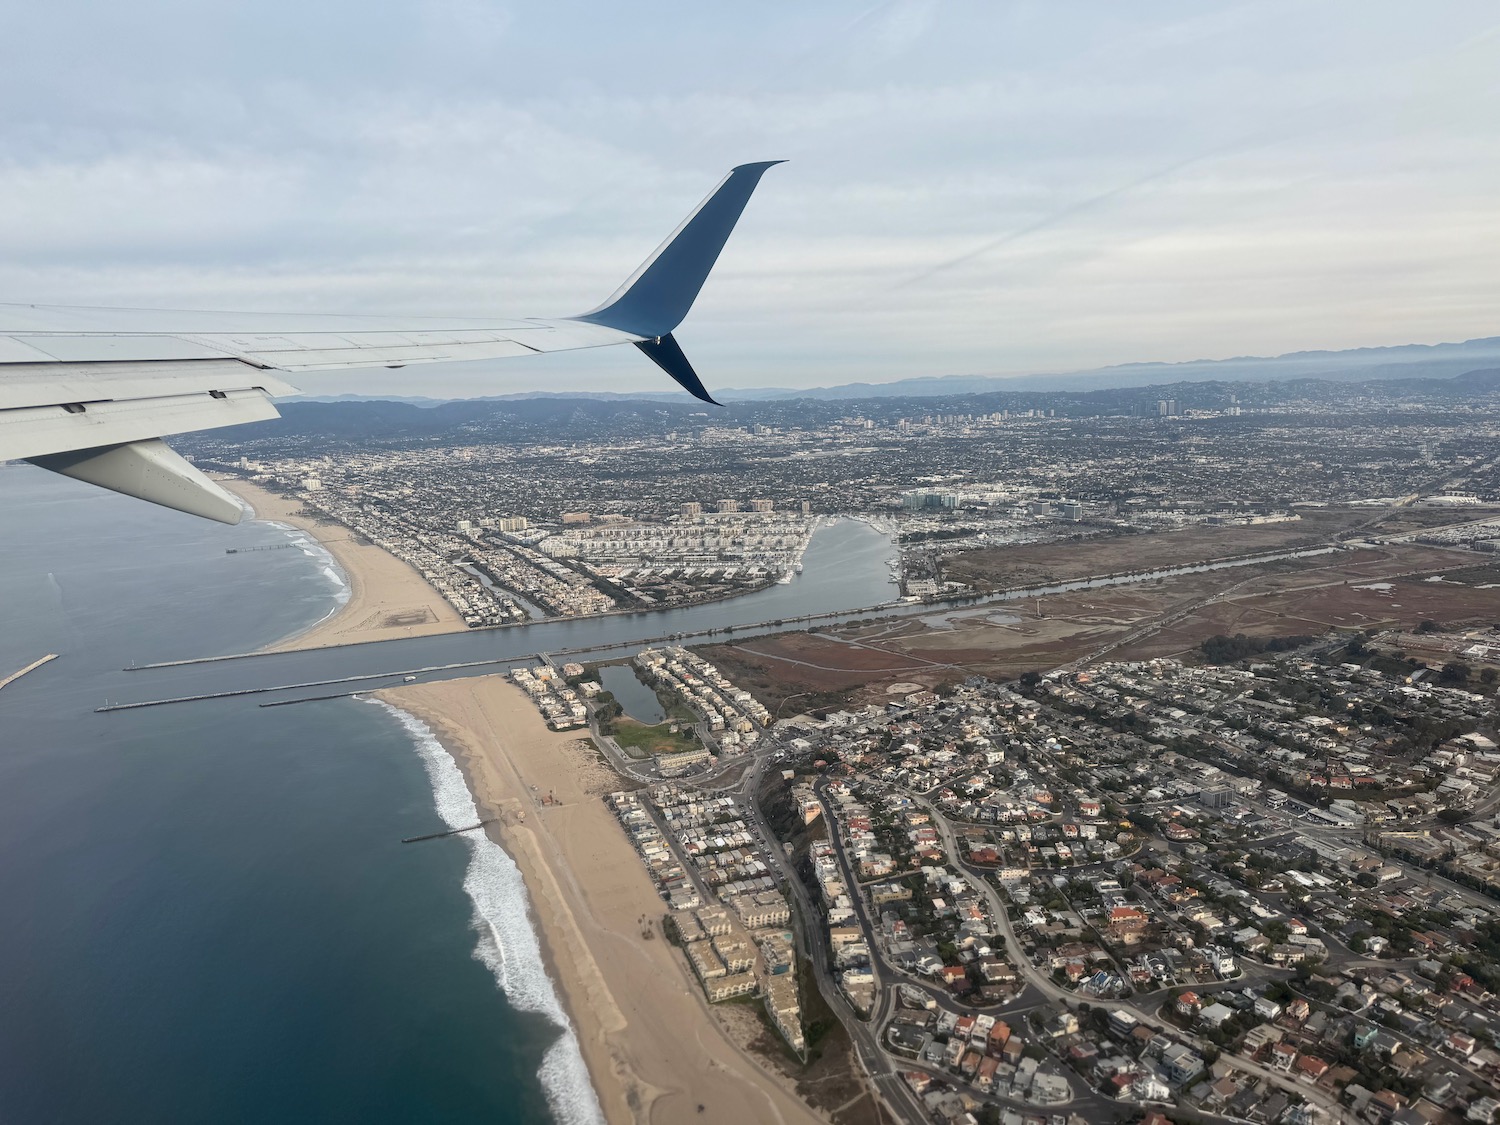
[573,161,785,339]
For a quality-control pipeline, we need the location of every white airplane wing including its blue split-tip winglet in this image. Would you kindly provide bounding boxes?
[0,161,780,524]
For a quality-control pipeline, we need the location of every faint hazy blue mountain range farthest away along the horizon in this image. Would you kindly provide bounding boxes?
[299,336,1500,407]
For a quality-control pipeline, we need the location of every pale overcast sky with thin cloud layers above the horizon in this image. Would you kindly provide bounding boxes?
[0,0,1500,395]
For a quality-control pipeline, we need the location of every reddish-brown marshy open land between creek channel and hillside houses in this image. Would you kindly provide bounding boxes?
[707,545,1500,714]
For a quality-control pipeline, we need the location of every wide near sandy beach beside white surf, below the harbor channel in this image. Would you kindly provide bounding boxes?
[380,677,825,1125]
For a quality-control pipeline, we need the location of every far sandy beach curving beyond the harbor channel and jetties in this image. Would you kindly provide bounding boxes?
[219,479,467,653]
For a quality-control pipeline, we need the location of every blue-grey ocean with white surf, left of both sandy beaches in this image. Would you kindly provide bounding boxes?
[0,467,579,1124]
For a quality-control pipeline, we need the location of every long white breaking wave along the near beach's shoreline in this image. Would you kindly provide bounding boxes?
[371,699,605,1125]
